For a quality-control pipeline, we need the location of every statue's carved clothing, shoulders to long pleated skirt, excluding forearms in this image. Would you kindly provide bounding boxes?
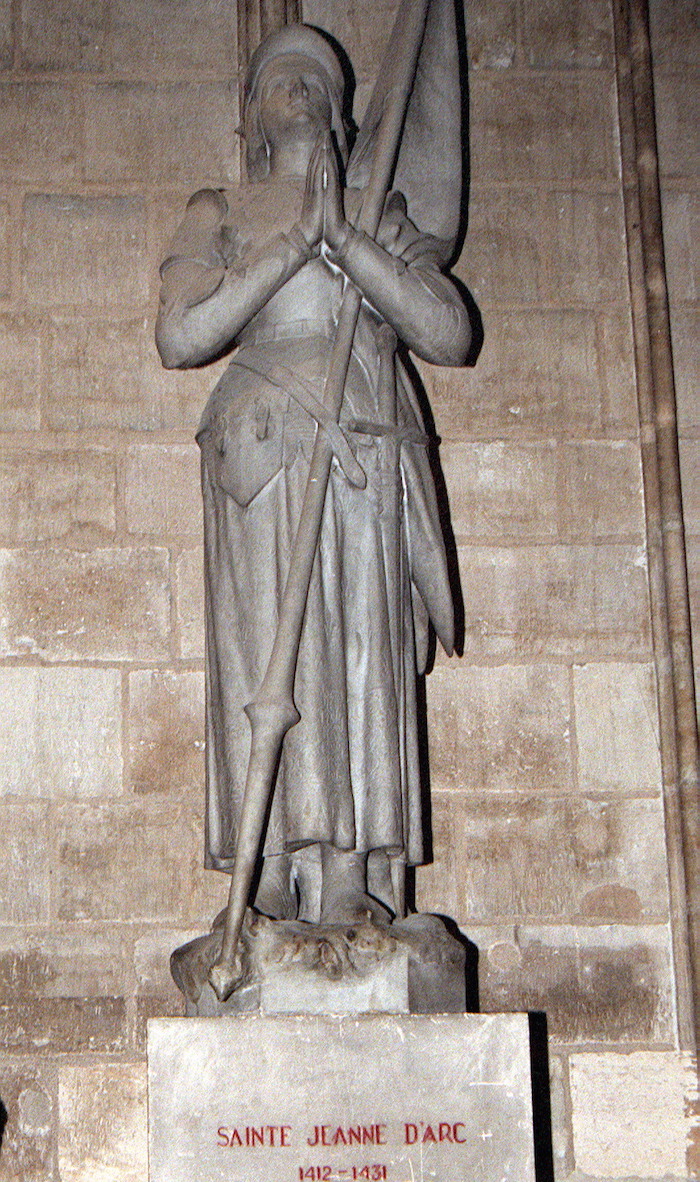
[162,180,453,871]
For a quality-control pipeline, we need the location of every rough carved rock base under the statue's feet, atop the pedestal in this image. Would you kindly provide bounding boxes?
[170,910,466,1018]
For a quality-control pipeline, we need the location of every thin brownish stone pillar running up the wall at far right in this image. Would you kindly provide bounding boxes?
[613,0,700,1051]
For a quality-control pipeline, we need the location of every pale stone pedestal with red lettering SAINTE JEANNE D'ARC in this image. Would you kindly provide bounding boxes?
[148,1014,534,1182]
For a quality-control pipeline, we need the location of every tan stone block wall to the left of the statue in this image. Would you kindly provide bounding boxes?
[0,0,239,1182]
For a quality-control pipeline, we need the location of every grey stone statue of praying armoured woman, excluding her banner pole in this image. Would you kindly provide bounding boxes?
[156,6,471,1007]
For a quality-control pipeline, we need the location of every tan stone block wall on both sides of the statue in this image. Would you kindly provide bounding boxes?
[0,0,700,1182]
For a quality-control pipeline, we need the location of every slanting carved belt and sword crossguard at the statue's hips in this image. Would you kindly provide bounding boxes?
[231,358,430,488]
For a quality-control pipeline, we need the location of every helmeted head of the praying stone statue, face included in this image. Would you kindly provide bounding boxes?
[244,25,348,181]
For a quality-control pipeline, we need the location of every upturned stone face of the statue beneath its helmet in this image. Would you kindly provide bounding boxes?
[258,53,332,145]
